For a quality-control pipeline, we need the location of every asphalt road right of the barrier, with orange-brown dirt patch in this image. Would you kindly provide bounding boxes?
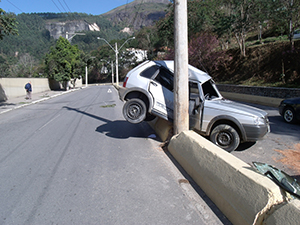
[232,103,300,181]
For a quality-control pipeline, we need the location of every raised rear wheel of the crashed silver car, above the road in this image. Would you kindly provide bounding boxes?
[123,98,147,124]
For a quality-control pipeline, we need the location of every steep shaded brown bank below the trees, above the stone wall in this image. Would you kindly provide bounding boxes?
[211,40,300,88]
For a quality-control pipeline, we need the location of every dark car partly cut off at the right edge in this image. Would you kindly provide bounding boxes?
[278,97,300,123]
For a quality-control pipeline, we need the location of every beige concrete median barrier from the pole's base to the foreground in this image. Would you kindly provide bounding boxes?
[168,131,300,225]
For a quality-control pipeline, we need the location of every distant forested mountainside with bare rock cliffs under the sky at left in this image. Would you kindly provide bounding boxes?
[0,0,169,59]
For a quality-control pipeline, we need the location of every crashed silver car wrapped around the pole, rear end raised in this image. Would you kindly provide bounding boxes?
[119,61,269,152]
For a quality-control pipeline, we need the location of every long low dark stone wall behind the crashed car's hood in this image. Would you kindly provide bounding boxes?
[217,84,300,99]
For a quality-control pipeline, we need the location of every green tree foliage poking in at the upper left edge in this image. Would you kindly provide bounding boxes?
[0,8,18,40]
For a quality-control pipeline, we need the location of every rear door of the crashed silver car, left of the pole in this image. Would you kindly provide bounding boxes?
[149,67,174,119]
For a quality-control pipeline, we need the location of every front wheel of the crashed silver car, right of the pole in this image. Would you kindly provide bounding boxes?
[210,124,240,152]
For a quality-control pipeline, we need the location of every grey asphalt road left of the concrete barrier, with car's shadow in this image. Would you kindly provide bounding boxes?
[0,86,230,225]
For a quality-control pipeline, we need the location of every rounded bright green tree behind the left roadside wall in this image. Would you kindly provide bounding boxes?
[45,37,85,88]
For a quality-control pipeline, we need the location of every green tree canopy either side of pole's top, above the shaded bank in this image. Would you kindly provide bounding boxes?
[152,0,300,56]
